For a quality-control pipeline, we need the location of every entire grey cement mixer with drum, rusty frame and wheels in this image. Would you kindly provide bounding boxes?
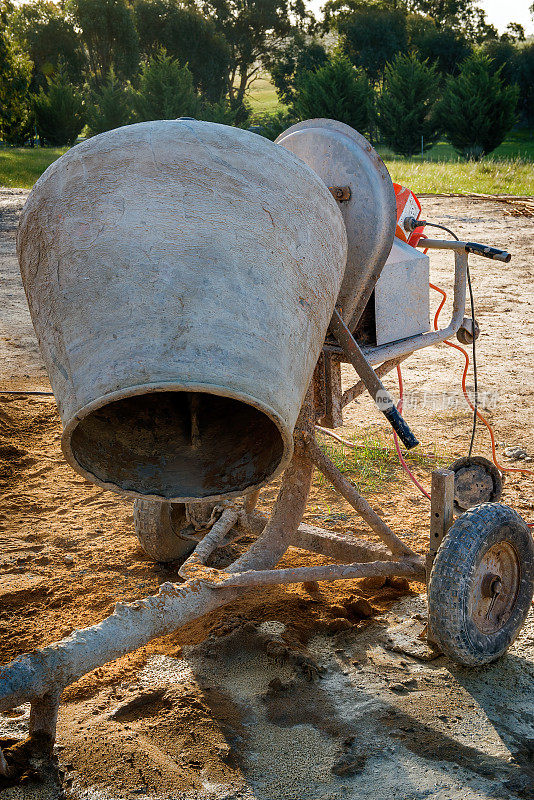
[0,119,534,774]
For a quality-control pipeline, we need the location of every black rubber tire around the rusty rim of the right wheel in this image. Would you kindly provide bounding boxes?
[428,503,534,667]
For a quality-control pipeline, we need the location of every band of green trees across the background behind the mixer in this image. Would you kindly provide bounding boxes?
[0,0,534,158]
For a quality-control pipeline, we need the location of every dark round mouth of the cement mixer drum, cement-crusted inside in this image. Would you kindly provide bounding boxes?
[68,391,284,500]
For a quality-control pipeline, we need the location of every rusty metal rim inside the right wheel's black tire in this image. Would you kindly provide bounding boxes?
[469,541,521,635]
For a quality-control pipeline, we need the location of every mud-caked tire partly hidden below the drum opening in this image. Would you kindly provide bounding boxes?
[134,500,196,564]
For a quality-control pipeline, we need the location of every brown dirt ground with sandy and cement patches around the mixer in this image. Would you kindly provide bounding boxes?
[0,190,534,800]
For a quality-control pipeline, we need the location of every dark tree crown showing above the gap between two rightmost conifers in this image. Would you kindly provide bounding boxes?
[407,14,472,75]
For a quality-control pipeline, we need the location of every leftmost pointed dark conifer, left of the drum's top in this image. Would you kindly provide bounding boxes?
[34,64,85,147]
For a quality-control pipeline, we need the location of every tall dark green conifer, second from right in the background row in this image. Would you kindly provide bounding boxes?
[377,53,440,156]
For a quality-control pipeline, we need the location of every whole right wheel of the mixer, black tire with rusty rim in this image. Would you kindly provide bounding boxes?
[428,503,534,666]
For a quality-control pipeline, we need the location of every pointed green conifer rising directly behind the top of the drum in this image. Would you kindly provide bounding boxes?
[133,48,200,122]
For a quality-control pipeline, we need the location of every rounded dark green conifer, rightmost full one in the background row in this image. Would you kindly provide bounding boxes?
[440,52,519,160]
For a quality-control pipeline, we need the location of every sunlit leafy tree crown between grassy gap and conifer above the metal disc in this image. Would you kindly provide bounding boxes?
[266,31,328,106]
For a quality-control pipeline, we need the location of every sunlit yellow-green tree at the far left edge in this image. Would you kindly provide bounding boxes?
[0,6,33,145]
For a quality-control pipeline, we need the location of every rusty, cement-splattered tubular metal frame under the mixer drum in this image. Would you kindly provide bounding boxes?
[0,389,425,774]
